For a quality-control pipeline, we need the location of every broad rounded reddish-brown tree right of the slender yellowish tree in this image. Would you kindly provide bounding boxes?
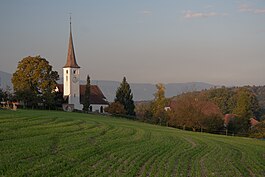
[169,92,223,131]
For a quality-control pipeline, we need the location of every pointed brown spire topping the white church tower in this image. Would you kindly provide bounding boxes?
[64,15,80,68]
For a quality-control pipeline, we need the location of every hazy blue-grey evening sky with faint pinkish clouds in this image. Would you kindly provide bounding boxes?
[0,0,265,86]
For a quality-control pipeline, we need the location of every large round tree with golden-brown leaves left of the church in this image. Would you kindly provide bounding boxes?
[12,56,59,107]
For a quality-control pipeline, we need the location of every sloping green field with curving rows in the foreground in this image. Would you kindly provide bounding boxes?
[0,110,265,177]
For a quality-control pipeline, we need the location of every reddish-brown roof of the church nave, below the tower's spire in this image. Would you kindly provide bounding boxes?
[57,84,109,105]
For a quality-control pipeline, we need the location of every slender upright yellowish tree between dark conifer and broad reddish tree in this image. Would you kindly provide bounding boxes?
[151,83,167,124]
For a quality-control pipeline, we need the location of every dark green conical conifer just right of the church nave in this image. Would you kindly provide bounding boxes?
[115,77,135,116]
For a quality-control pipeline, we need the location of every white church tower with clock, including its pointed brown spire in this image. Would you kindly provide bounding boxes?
[63,17,83,110]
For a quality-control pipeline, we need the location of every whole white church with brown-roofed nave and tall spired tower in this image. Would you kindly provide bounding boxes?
[57,18,109,113]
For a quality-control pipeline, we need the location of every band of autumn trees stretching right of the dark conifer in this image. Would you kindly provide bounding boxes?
[136,84,264,135]
